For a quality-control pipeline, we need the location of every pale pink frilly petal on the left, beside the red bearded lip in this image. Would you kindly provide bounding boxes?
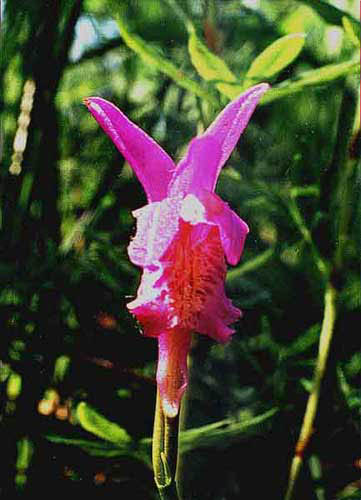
[128,198,181,267]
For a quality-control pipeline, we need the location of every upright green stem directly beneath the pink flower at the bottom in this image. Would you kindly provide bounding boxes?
[152,390,178,500]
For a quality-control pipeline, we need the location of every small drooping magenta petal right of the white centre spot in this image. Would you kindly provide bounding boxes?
[198,190,249,266]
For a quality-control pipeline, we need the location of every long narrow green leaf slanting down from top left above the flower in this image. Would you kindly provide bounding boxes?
[115,9,217,105]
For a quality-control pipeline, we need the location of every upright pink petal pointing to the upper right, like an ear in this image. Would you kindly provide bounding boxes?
[203,83,269,191]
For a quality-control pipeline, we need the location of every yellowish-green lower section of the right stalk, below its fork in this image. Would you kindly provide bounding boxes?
[285,283,337,500]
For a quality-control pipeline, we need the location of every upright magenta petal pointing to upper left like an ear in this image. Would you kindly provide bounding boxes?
[84,97,175,201]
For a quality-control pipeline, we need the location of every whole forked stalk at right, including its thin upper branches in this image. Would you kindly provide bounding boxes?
[285,87,360,500]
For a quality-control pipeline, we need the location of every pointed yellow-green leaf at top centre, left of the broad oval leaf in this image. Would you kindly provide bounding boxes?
[188,28,236,97]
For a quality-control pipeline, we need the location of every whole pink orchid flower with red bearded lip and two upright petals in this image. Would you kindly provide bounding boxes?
[85,84,268,417]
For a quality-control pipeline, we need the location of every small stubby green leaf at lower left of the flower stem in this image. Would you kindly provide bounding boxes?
[76,401,132,448]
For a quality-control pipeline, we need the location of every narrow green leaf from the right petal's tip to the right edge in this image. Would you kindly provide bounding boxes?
[261,61,360,104]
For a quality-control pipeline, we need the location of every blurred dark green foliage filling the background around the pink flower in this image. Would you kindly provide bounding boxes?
[0,0,361,500]
